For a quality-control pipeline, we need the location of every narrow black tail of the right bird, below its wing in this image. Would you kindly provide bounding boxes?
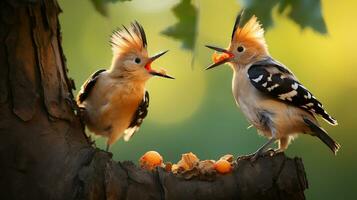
[304,118,341,155]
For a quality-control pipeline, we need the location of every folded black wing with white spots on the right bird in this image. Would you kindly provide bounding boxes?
[248,58,337,125]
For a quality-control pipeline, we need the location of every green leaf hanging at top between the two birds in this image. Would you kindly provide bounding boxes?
[161,0,198,50]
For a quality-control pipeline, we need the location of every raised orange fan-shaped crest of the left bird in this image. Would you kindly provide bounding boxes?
[110,21,147,54]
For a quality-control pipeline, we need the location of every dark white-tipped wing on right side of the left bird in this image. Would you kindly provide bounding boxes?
[124,91,149,141]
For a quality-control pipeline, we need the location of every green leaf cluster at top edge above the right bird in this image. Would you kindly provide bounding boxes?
[240,0,327,34]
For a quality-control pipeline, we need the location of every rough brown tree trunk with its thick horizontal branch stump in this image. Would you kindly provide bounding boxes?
[0,0,307,200]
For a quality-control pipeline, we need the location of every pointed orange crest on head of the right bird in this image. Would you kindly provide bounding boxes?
[232,15,266,46]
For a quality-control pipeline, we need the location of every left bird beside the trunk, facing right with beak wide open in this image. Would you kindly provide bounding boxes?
[77,21,174,151]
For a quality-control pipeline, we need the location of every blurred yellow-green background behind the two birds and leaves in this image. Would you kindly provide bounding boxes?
[59,0,357,199]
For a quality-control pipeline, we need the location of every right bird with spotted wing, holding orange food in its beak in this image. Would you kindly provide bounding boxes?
[206,11,340,160]
